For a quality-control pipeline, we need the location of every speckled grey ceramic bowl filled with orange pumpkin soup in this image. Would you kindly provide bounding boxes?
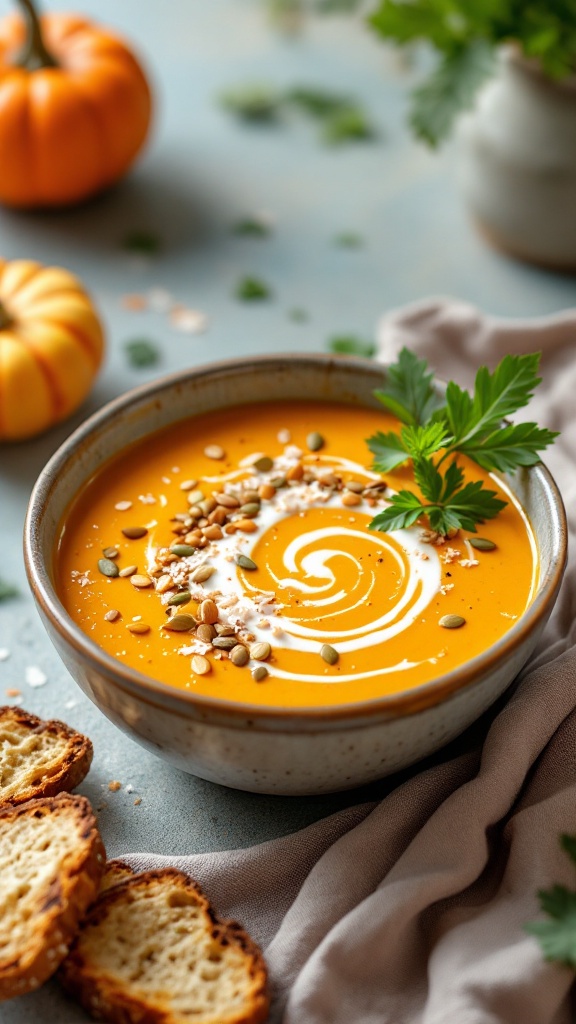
[25,354,566,795]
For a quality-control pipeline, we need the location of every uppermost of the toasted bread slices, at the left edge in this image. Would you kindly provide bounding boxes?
[0,707,92,806]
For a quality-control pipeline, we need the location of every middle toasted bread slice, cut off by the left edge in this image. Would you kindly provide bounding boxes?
[0,793,106,1000]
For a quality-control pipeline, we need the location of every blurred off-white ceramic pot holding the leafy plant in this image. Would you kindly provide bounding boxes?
[459,47,576,270]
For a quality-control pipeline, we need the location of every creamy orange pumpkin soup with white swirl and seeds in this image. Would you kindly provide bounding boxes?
[55,401,537,707]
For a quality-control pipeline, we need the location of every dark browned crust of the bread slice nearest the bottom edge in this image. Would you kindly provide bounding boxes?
[58,867,270,1024]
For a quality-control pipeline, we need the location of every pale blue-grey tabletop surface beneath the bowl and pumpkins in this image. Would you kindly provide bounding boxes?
[0,0,576,1024]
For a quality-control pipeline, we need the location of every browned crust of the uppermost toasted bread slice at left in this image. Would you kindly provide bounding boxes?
[0,706,93,807]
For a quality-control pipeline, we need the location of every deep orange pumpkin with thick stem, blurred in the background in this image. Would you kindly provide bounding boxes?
[0,0,151,208]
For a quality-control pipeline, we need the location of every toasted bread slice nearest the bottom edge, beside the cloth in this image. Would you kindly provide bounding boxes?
[58,868,269,1024]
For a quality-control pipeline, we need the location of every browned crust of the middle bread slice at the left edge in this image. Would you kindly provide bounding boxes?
[0,793,106,1001]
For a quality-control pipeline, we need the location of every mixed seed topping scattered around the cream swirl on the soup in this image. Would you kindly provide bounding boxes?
[90,431,496,683]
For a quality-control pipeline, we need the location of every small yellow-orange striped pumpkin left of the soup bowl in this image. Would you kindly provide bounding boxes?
[0,260,104,440]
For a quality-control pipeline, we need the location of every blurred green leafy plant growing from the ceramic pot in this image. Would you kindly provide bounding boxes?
[369,0,576,145]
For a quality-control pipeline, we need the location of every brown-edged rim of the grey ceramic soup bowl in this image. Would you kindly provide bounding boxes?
[24,352,568,728]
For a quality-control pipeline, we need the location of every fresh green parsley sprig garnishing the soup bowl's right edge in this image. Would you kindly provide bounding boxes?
[367,348,558,534]
